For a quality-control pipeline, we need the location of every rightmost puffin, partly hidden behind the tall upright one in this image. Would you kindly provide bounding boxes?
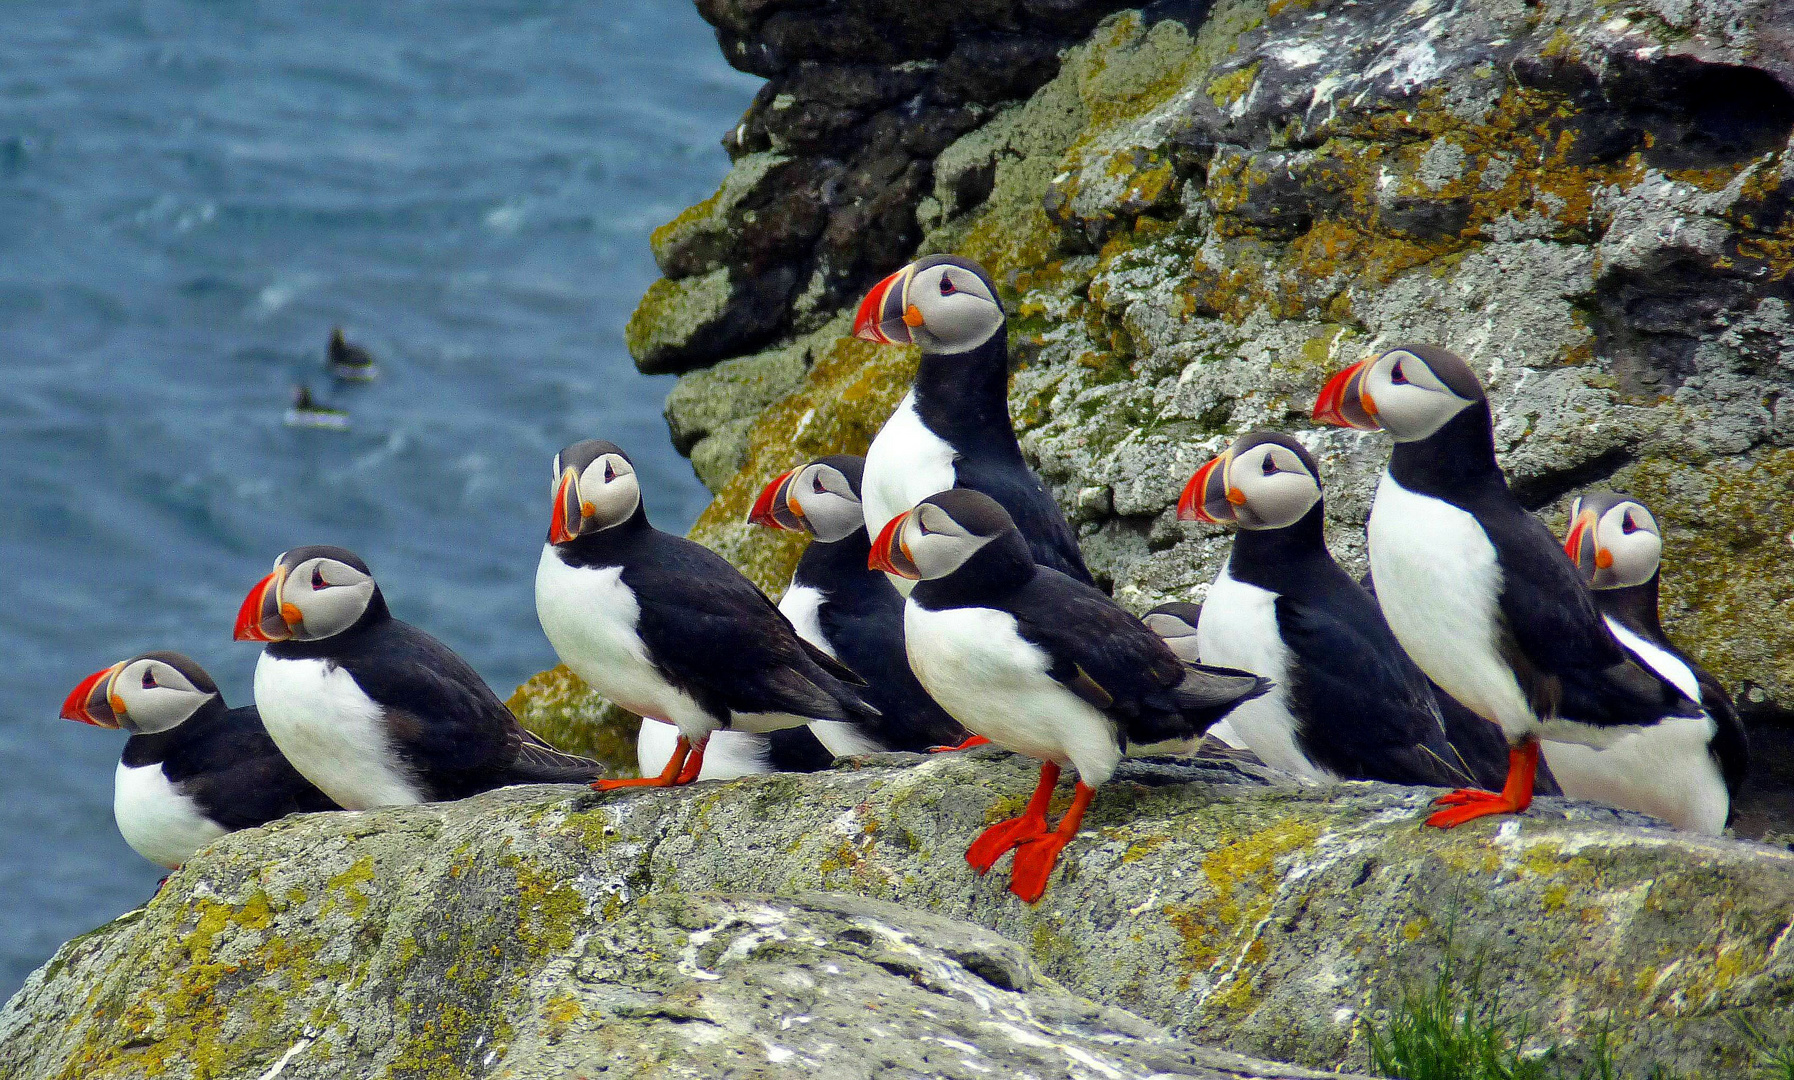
[1543,492,1749,836]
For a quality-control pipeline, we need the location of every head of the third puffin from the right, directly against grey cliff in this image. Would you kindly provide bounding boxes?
[1177,431,1320,529]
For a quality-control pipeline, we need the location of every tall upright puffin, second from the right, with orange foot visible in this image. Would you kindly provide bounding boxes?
[1313,344,1706,829]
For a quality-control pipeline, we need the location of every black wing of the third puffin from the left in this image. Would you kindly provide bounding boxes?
[623,533,877,721]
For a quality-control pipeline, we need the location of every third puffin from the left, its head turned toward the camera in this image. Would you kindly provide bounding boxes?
[536,432,879,791]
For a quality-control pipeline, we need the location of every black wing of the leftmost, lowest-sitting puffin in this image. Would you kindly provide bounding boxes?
[163,705,343,829]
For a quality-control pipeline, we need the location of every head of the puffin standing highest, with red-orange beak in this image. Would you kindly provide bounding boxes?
[854,255,1003,353]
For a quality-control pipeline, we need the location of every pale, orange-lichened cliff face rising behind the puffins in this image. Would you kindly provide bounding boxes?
[638,0,1794,701]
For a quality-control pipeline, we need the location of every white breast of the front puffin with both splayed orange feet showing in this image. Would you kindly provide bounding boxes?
[904,601,1121,788]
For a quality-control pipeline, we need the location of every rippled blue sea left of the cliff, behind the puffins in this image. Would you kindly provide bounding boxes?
[0,0,757,996]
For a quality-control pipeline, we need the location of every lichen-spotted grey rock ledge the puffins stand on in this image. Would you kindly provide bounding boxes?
[0,750,1794,1080]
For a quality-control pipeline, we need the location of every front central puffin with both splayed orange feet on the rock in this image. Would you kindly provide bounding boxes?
[872,488,1270,904]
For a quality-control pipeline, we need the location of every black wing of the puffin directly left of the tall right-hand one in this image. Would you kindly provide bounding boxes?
[1277,588,1478,786]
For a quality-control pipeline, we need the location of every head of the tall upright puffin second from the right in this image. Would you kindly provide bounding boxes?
[1315,344,1487,443]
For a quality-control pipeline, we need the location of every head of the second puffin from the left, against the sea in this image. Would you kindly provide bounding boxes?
[235,544,386,640]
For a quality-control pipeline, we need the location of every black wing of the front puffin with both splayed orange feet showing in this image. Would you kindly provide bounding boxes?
[1003,569,1270,746]
